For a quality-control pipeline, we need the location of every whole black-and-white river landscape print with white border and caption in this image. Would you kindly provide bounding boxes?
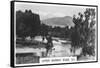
[11,1,98,66]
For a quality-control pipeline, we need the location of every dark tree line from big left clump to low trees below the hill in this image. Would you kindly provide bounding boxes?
[16,10,70,39]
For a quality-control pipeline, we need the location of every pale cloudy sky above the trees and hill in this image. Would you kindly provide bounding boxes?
[15,2,94,20]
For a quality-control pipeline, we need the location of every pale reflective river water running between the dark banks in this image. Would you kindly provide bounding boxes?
[16,36,80,57]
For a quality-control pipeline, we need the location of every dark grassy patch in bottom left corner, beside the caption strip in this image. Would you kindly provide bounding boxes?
[16,53,40,64]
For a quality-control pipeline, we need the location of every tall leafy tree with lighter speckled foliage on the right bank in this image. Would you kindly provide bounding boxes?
[71,9,95,55]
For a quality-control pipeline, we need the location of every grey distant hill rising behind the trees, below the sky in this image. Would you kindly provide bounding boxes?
[41,16,74,27]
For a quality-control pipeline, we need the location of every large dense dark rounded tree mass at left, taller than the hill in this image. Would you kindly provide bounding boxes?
[16,10,40,38]
